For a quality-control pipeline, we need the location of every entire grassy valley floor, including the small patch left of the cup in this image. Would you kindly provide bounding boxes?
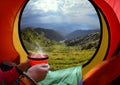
[29,44,95,71]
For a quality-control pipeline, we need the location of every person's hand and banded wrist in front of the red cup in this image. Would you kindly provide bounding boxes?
[20,64,49,85]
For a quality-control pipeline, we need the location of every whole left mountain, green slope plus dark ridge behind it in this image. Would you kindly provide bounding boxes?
[21,27,62,51]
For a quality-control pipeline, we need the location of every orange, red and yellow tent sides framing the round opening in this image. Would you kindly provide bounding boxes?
[0,0,120,84]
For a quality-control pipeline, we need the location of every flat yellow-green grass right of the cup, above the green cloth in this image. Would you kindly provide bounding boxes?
[47,50,95,70]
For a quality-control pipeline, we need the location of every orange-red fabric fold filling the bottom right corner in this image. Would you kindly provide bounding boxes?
[83,52,120,85]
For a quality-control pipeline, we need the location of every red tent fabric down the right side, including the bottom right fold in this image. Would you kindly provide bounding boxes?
[84,0,120,85]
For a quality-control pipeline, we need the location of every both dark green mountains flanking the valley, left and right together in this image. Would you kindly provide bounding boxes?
[21,27,100,50]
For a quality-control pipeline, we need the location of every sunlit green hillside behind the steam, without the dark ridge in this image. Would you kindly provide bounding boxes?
[21,27,55,51]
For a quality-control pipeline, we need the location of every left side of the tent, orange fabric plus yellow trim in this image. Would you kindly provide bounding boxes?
[0,0,27,62]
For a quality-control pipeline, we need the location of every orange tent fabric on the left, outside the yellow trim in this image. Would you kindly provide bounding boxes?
[0,0,25,62]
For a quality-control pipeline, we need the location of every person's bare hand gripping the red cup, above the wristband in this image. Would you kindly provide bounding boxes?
[27,64,50,82]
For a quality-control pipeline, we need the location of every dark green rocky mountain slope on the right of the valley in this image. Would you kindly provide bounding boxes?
[65,32,100,49]
